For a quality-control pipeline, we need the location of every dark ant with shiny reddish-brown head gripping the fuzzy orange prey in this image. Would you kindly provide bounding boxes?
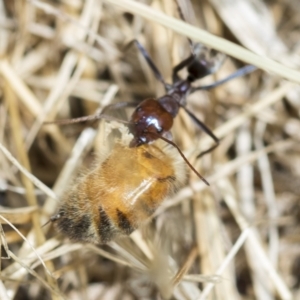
[46,40,256,185]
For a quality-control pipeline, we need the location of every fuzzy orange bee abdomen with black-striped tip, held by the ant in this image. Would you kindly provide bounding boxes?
[51,137,186,244]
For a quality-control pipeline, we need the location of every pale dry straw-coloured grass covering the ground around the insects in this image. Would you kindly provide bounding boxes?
[0,0,300,300]
